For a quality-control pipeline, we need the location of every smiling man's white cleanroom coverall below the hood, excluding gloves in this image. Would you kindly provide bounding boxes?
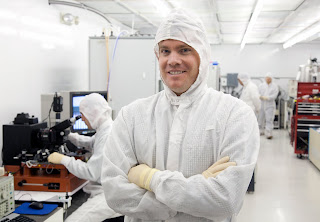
[102,89,259,222]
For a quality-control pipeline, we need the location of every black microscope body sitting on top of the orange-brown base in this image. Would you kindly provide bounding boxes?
[2,113,80,165]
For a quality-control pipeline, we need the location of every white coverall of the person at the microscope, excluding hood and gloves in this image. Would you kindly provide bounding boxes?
[62,122,121,222]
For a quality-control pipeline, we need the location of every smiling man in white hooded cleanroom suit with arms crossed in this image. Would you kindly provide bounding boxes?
[101,9,260,222]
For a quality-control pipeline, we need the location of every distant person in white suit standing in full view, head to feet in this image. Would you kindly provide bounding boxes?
[258,72,279,139]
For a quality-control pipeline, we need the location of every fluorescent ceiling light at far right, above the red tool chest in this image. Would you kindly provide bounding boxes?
[283,21,320,49]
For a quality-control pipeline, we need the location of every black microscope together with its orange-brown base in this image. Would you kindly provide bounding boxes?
[2,113,86,192]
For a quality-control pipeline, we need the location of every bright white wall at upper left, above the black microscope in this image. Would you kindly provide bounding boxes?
[0,0,108,156]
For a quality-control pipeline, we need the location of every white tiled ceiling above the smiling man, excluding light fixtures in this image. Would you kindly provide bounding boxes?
[74,0,320,44]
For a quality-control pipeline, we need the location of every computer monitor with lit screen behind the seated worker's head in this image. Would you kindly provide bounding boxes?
[70,91,107,134]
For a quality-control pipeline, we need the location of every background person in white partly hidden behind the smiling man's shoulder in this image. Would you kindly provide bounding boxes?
[238,73,261,116]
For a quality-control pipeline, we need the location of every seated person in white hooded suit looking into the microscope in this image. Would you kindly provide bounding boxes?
[48,93,121,222]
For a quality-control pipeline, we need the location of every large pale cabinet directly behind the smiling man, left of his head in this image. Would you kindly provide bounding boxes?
[89,37,159,118]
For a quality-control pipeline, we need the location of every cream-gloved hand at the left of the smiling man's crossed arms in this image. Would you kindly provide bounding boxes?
[128,164,159,191]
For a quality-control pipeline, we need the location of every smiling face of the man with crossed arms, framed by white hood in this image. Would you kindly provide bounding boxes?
[158,39,200,96]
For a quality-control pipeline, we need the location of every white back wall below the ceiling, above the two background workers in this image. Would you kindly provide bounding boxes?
[211,44,320,77]
